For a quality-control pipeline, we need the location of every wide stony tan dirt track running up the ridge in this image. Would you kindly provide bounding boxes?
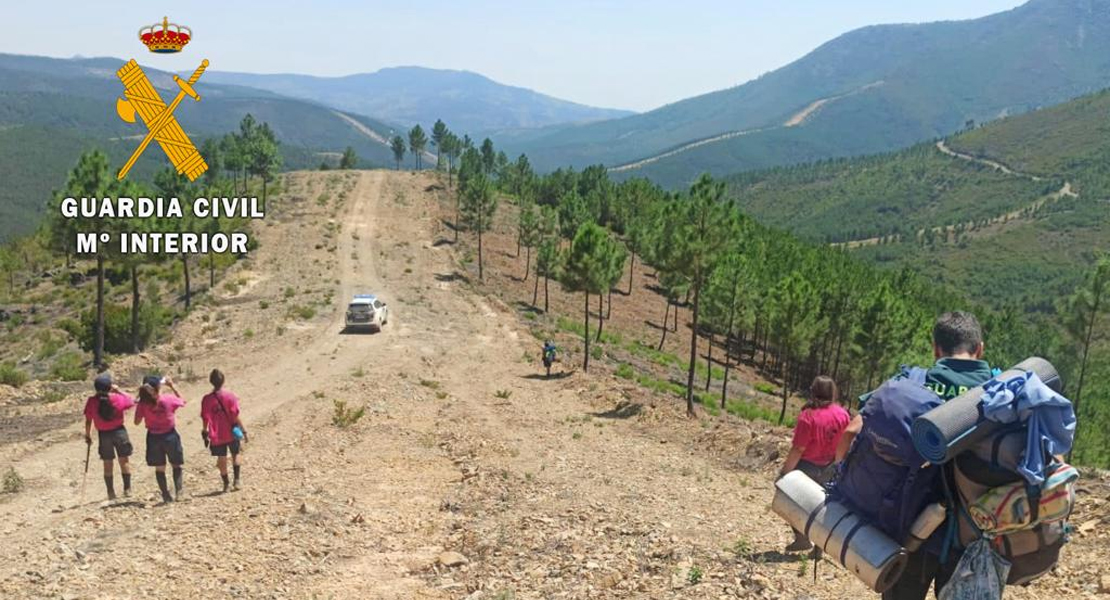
[0,171,1110,599]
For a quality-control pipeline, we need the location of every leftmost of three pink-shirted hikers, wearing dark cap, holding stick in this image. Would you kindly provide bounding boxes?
[84,373,135,500]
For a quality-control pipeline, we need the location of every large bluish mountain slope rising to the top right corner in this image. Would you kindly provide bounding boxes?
[502,0,1110,186]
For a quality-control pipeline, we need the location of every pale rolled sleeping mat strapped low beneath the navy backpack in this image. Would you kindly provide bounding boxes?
[770,470,907,593]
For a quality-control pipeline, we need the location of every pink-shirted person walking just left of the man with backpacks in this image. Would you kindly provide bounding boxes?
[778,375,851,552]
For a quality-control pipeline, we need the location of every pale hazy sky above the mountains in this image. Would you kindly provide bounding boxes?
[0,0,1022,111]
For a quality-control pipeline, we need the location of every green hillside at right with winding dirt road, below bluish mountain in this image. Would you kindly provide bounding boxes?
[728,82,1110,312]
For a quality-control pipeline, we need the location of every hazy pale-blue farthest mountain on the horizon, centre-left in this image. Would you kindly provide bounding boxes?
[209,67,633,134]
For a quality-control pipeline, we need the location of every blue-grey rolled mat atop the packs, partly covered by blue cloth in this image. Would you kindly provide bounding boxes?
[911,356,1063,464]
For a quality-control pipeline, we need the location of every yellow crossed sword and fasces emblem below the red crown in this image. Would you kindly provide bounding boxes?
[115,59,209,181]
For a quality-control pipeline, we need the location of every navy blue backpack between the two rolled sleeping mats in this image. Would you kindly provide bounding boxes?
[829,367,942,545]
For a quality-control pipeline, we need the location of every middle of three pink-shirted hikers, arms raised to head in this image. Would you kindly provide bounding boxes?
[135,376,185,502]
